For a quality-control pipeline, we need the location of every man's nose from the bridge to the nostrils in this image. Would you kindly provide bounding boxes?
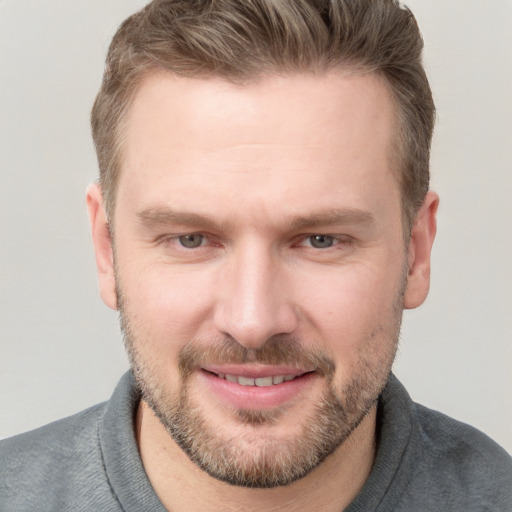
[214,244,298,349]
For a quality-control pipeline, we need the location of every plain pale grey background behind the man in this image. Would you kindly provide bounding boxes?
[0,0,512,452]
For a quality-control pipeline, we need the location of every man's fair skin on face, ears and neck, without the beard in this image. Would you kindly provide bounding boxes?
[87,72,438,511]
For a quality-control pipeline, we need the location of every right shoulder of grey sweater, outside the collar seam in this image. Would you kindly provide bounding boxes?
[412,404,512,510]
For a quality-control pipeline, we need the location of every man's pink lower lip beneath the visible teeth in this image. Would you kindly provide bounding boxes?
[199,370,316,410]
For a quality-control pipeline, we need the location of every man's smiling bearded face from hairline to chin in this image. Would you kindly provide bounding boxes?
[89,72,436,487]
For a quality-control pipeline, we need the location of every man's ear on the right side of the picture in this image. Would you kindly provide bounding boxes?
[404,191,439,309]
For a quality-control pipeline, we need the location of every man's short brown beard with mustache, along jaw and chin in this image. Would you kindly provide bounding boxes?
[118,272,405,488]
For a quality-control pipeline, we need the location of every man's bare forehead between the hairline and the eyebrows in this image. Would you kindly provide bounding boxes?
[118,72,398,224]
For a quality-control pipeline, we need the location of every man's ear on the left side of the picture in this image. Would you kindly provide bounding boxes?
[87,183,117,309]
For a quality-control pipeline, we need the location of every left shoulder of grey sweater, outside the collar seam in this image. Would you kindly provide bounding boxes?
[0,403,121,510]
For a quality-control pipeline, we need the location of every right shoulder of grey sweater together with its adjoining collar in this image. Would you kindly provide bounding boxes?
[372,375,512,512]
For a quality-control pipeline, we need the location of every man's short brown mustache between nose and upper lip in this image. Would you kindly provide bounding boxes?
[178,336,336,380]
